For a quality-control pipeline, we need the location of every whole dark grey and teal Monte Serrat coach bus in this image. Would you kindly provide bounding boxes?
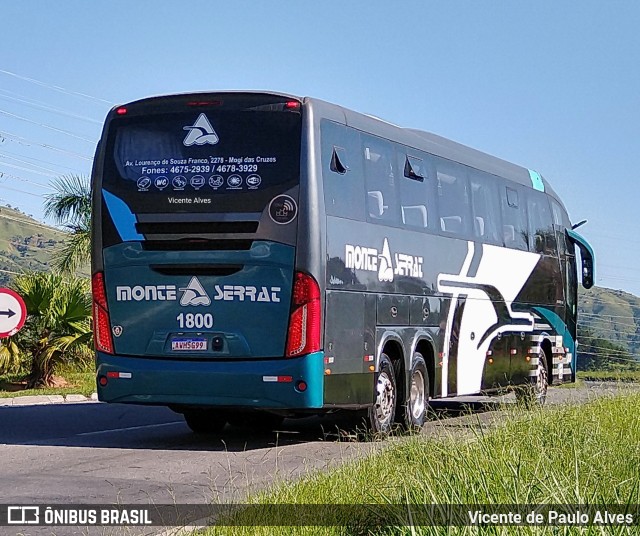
[92,91,594,433]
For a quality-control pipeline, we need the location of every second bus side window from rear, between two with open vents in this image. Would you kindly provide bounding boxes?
[362,134,401,225]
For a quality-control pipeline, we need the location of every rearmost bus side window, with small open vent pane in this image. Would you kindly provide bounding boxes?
[320,120,365,221]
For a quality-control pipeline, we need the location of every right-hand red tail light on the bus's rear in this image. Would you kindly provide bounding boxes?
[285,272,321,357]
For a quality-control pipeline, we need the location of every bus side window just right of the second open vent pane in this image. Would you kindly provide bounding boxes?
[436,159,472,237]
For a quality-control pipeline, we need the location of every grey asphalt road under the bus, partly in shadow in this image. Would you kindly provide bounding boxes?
[0,384,636,534]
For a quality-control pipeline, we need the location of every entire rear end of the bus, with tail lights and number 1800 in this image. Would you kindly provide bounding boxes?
[92,93,323,411]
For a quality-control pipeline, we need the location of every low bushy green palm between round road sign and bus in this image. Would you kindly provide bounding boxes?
[11,272,93,388]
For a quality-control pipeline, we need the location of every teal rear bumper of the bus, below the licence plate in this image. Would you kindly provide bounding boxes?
[96,352,324,409]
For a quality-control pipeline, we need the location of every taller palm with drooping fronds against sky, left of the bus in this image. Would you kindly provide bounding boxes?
[44,174,91,274]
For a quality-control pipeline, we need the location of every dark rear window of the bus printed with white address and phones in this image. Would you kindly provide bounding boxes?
[103,109,302,213]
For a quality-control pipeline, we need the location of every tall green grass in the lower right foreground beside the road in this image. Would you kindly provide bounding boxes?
[204,394,640,536]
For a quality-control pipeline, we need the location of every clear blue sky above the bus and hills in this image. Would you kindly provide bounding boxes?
[0,0,640,295]
